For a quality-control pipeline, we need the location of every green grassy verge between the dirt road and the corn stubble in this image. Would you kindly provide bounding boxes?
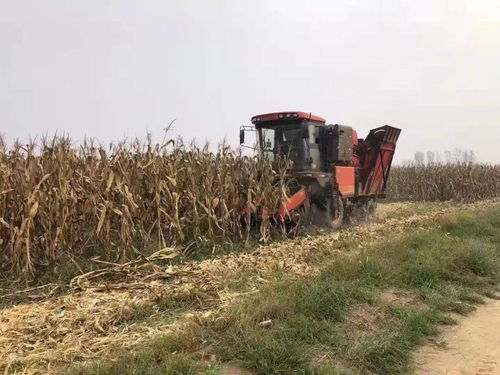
[74,207,500,375]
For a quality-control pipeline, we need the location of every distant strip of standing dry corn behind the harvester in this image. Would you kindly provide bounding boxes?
[387,163,500,202]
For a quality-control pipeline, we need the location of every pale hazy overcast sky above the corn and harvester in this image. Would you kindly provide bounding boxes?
[0,0,500,162]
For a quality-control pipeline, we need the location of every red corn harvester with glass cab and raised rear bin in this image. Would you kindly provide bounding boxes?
[240,112,401,228]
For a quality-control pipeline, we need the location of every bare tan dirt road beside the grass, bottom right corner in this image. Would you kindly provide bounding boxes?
[415,299,500,375]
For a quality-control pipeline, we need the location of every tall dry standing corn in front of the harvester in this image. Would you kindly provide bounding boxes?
[0,137,286,274]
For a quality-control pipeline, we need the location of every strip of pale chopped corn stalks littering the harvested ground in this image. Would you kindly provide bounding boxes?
[0,201,491,374]
